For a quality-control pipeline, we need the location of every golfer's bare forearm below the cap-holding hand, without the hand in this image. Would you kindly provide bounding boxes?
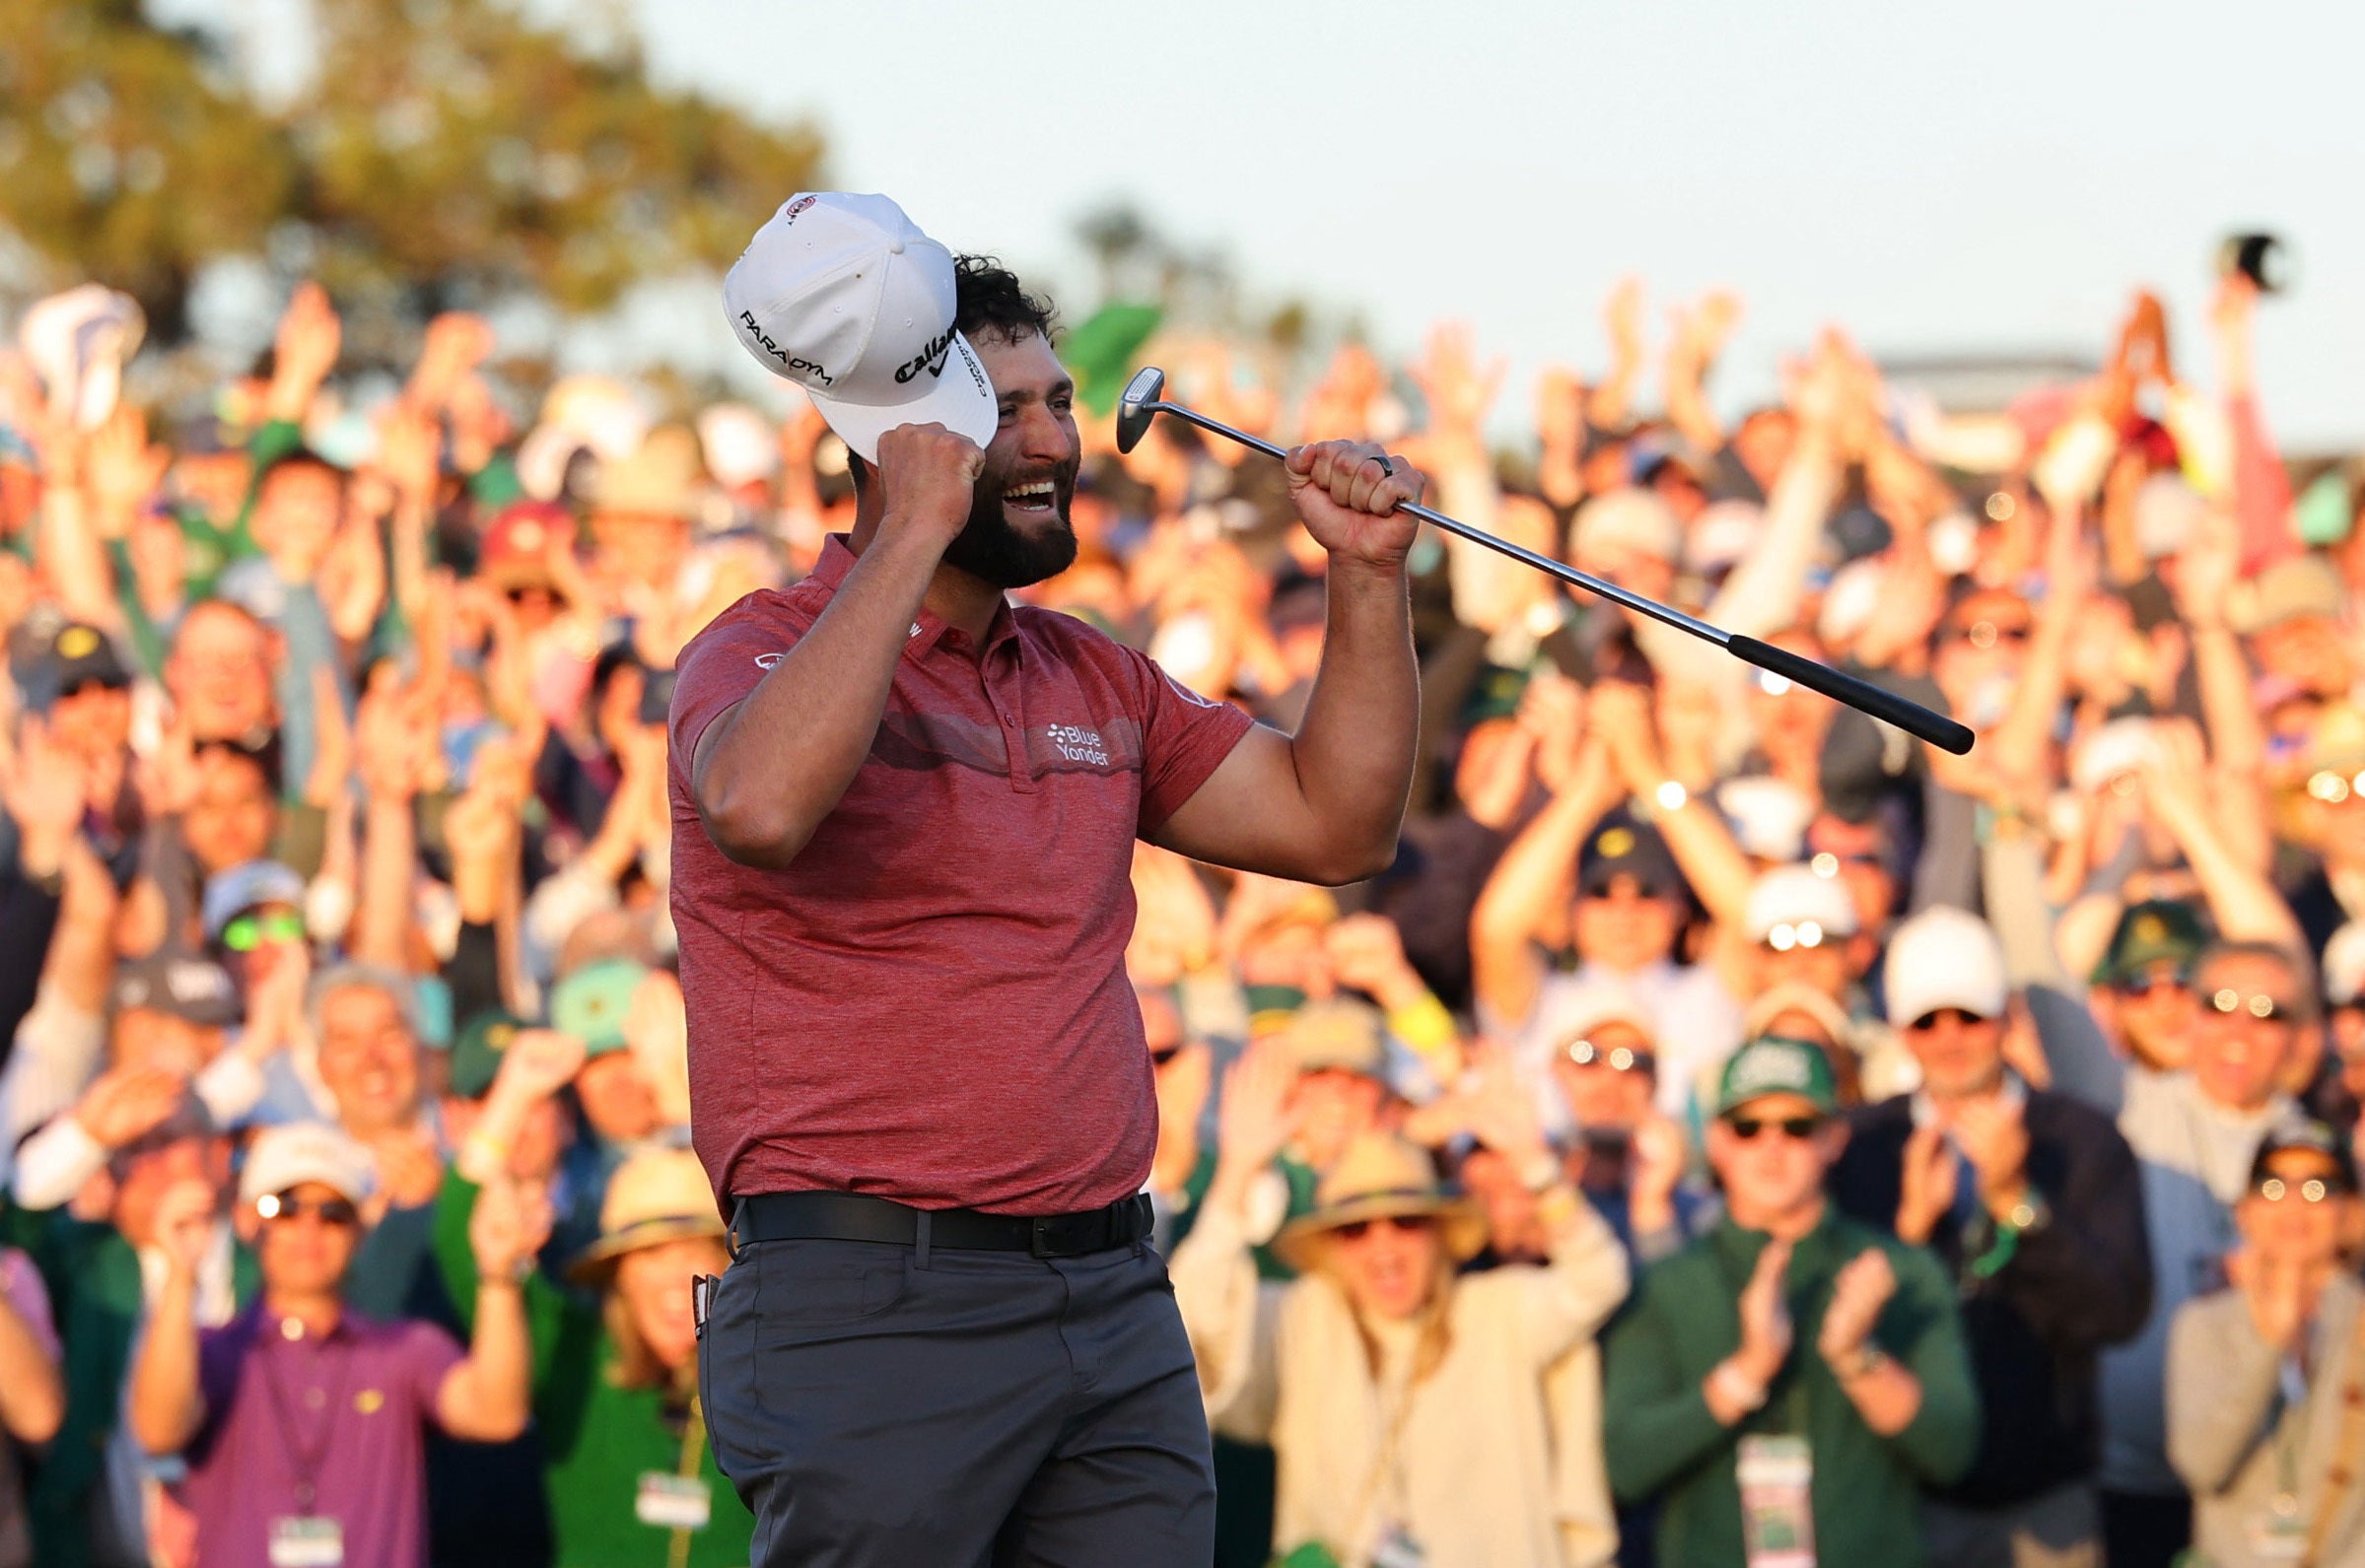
[691,532,943,870]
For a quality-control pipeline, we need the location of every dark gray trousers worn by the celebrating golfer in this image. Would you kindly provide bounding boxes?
[698,1242,1216,1568]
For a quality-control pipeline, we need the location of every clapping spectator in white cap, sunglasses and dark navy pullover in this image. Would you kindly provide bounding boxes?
[1831,906,2152,1568]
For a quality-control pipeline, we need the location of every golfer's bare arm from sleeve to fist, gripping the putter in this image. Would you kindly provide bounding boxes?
[1149,440,1422,884]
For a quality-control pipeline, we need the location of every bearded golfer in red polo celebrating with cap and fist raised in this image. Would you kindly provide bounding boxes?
[671,194,1422,1563]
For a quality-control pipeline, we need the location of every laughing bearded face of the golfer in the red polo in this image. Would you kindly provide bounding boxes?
[943,329,1083,589]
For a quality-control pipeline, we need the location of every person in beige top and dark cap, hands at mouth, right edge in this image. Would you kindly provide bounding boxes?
[2166,1124,2365,1568]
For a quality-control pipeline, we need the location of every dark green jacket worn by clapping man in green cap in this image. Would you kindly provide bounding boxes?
[1604,1208,1980,1568]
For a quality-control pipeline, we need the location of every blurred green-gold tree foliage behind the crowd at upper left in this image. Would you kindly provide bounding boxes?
[0,0,820,338]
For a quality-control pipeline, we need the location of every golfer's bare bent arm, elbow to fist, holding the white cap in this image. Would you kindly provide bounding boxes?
[691,426,986,870]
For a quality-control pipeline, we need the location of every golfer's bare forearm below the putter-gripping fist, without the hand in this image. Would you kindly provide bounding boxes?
[1288,556,1422,882]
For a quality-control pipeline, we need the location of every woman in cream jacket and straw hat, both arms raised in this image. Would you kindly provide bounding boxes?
[1173,1043,1628,1568]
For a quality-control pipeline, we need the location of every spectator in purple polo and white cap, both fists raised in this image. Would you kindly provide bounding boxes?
[130,1124,549,1568]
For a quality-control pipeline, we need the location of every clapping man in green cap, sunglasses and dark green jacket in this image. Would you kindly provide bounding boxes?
[1606,1036,1980,1568]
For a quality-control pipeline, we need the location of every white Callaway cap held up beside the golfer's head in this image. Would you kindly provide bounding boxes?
[724,191,998,461]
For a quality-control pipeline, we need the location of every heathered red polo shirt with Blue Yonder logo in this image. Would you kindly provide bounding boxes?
[671,539,1249,1213]
